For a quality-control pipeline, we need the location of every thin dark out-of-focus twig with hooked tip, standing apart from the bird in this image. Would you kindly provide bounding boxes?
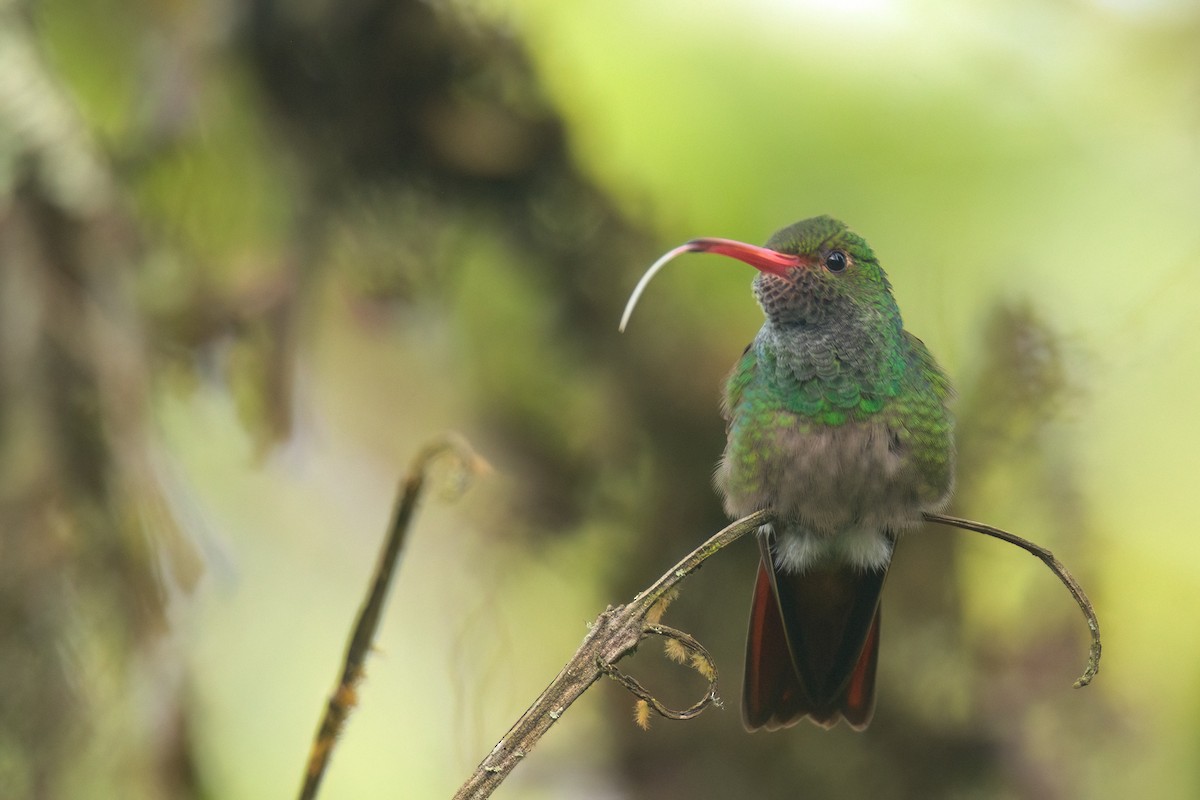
[299,434,488,800]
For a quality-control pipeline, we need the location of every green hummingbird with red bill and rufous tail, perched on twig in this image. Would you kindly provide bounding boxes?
[622,217,954,730]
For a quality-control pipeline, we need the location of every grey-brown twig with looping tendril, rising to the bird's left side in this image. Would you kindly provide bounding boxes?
[455,511,774,800]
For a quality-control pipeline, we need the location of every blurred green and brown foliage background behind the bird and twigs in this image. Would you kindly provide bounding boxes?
[0,0,1200,800]
